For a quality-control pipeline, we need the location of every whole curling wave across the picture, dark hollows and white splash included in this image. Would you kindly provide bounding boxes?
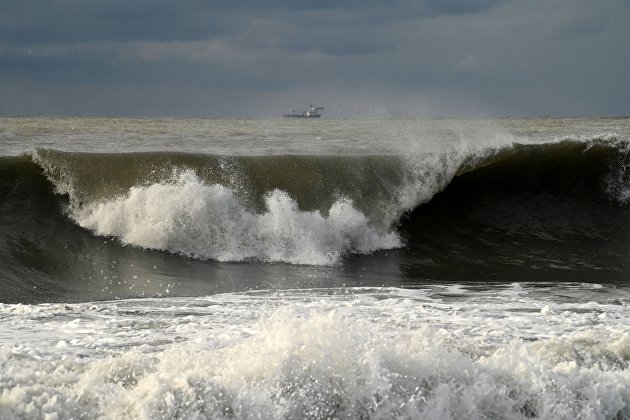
[0,138,630,302]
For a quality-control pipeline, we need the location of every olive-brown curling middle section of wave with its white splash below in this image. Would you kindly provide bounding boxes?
[33,150,464,265]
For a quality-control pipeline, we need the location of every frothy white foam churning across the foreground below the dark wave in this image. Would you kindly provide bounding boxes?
[0,284,630,419]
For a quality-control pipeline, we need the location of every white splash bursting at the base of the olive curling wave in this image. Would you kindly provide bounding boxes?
[71,171,401,265]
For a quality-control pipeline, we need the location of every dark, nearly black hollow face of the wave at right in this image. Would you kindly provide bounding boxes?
[402,140,630,281]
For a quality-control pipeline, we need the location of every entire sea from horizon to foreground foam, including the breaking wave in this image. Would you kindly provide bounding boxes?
[0,118,630,420]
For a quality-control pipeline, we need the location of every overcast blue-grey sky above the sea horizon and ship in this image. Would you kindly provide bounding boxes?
[0,0,630,118]
